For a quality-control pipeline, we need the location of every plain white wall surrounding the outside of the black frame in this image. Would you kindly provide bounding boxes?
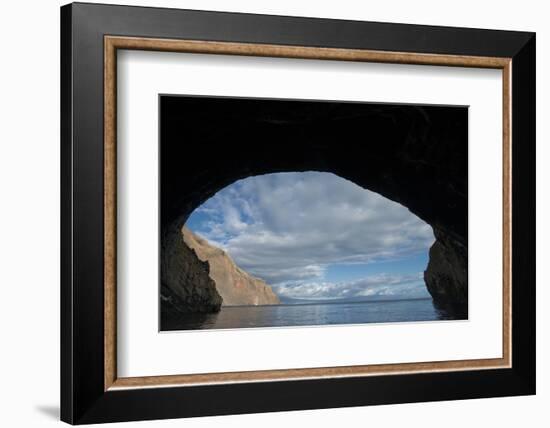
[0,0,550,428]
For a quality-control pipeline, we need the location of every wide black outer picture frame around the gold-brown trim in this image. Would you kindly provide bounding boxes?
[61,3,536,424]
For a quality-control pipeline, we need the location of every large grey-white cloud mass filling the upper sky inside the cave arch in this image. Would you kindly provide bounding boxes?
[190,172,434,289]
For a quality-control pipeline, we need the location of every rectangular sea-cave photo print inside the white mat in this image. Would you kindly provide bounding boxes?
[159,95,468,331]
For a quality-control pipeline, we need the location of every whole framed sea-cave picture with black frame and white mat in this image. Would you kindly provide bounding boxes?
[61,3,535,424]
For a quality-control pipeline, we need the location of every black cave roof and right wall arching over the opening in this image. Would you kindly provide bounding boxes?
[160,95,468,317]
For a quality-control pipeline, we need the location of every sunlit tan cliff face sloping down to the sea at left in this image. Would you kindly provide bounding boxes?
[181,226,280,306]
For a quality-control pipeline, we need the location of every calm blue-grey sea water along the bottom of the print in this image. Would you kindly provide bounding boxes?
[162,298,465,330]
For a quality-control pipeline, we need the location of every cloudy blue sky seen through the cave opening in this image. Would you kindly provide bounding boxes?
[186,171,434,301]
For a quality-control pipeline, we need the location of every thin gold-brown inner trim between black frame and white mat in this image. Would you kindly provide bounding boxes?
[104,36,512,391]
